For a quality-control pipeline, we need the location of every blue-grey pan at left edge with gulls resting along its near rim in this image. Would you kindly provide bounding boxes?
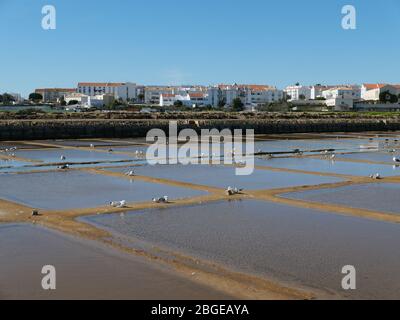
[0,171,206,210]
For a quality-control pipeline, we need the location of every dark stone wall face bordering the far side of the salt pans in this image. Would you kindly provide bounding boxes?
[0,119,400,141]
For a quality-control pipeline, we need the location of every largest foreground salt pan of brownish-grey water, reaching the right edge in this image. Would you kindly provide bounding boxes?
[86,201,400,299]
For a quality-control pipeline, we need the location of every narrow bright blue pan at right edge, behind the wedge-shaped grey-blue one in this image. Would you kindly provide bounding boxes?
[255,158,400,177]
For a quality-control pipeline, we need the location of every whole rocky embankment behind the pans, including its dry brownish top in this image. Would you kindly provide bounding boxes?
[0,112,400,140]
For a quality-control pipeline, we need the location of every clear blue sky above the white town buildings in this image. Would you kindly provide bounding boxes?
[0,0,400,95]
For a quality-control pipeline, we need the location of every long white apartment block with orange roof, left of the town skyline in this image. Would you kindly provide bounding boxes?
[77,82,137,101]
